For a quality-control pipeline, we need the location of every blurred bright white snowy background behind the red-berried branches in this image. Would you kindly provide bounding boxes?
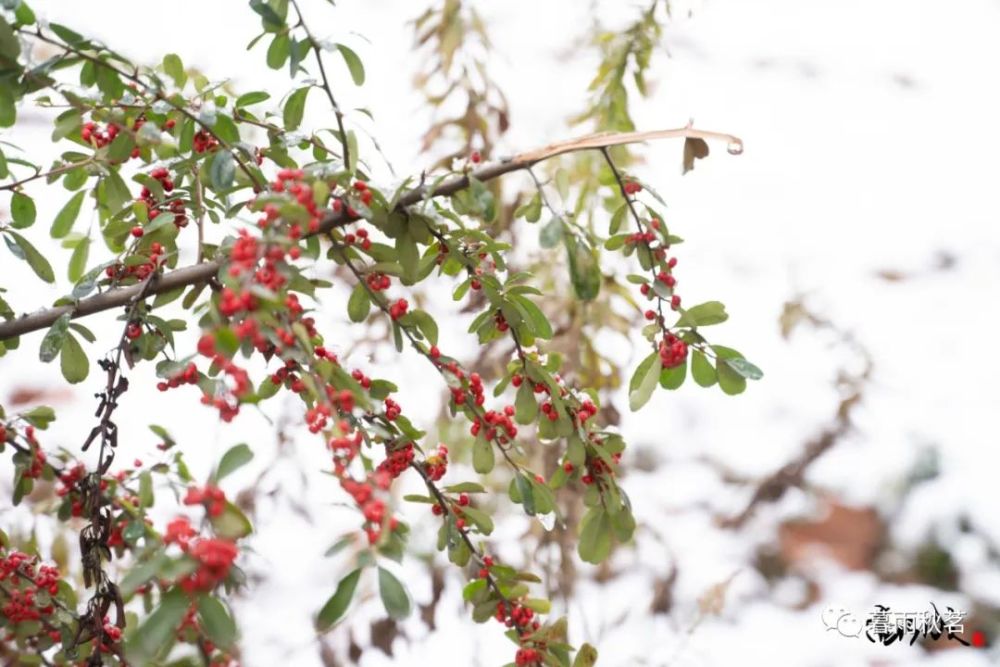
[0,0,1000,667]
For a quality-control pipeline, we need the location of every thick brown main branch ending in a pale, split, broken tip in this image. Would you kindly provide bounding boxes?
[0,128,742,341]
